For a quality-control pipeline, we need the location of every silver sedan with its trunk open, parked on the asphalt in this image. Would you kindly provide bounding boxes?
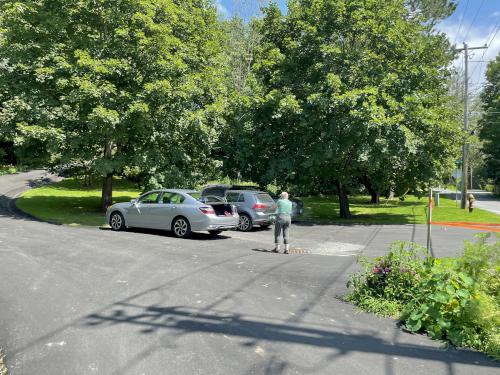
[106,189,239,238]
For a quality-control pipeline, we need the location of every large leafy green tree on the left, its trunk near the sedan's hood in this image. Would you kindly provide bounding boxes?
[0,0,224,209]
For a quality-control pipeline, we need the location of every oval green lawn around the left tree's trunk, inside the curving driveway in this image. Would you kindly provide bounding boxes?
[16,179,141,226]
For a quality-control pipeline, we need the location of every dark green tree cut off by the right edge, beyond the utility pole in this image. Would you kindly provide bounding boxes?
[479,54,500,191]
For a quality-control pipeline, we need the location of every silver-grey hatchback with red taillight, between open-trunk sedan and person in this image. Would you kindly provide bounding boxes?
[201,185,276,232]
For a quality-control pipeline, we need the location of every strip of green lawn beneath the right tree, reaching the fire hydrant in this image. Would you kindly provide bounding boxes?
[302,196,500,224]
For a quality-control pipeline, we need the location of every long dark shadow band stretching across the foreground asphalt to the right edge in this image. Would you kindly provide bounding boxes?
[83,304,500,367]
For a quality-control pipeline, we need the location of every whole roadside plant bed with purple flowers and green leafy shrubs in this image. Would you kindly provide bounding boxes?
[345,235,500,360]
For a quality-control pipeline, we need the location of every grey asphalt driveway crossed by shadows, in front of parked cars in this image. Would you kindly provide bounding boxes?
[0,171,499,375]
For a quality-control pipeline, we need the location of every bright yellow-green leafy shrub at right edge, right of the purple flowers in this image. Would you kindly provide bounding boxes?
[401,236,500,359]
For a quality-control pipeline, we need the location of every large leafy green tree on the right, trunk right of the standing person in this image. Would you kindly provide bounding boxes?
[242,0,459,217]
